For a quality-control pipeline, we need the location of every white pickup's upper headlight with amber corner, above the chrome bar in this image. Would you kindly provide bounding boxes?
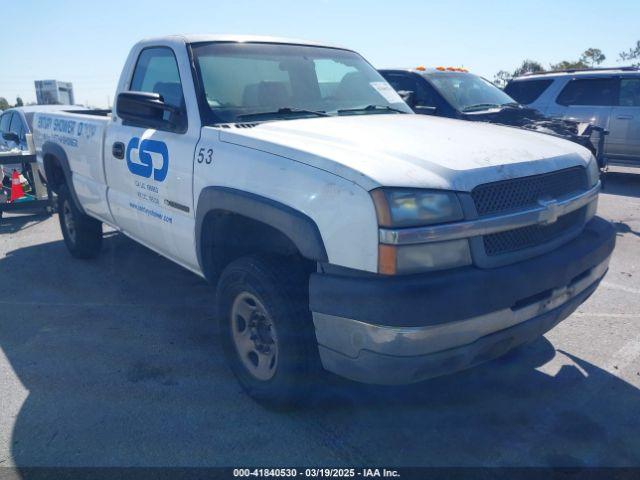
[371,188,464,228]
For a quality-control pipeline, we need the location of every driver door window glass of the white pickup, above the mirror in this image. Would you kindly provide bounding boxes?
[130,47,185,115]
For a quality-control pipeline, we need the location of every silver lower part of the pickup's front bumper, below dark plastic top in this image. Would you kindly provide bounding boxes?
[313,258,609,384]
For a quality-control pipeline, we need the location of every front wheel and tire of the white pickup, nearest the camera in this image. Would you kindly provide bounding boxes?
[217,255,320,408]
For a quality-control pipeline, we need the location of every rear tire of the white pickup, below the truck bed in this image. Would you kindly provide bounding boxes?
[58,185,102,259]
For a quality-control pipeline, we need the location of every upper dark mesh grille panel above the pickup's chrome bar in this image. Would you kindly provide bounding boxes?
[471,167,588,217]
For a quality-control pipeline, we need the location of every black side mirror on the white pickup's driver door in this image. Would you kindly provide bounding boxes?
[116,92,186,131]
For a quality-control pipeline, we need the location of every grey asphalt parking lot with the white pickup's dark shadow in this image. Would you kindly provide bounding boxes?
[0,170,640,468]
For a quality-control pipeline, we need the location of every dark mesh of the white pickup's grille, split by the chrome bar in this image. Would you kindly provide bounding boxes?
[471,167,588,257]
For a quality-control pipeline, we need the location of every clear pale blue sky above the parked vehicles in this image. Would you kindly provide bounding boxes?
[0,0,640,107]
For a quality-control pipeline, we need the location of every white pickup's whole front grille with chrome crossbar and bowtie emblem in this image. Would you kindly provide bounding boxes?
[378,167,600,268]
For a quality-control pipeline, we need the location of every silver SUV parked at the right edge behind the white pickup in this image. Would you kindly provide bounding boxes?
[505,67,640,167]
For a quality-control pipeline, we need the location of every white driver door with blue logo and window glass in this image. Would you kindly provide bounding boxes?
[104,46,200,268]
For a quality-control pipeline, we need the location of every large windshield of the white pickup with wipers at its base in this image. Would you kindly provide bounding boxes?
[193,43,411,124]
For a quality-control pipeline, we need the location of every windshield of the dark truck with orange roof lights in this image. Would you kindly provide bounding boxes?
[427,72,516,112]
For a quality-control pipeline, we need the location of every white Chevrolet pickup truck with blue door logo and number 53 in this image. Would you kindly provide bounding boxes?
[34,36,615,403]
